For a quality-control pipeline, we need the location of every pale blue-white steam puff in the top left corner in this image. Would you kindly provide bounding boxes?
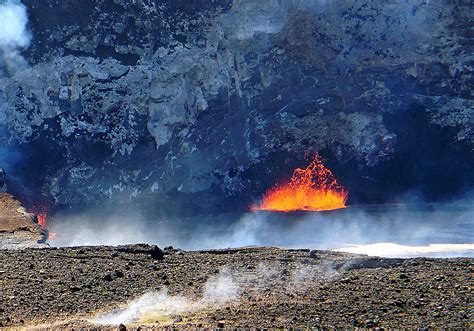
[0,0,31,77]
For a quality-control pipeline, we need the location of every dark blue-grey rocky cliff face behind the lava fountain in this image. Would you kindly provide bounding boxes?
[0,0,473,213]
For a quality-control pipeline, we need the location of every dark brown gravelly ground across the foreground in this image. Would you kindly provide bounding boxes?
[0,245,473,328]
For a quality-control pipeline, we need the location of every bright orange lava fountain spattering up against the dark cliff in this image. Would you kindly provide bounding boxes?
[250,154,348,212]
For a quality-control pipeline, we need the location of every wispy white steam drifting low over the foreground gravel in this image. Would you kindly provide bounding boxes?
[90,262,340,325]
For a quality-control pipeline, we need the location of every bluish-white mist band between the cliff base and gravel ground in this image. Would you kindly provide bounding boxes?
[49,198,474,256]
